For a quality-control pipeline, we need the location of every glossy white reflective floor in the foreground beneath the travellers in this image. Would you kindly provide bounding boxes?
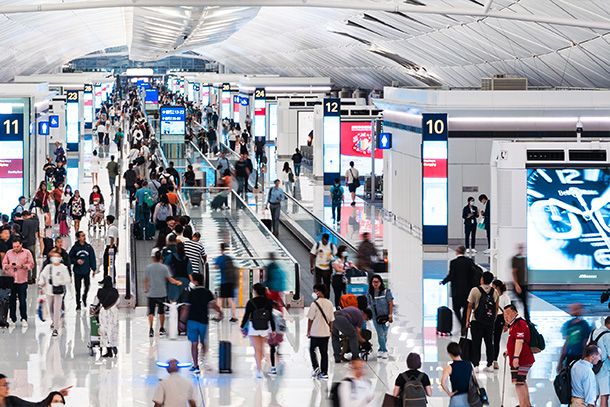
[0,145,599,407]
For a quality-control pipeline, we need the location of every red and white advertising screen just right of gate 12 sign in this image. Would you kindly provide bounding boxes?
[341,121,383,175]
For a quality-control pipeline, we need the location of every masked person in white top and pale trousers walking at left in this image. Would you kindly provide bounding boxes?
[38,249,72,336]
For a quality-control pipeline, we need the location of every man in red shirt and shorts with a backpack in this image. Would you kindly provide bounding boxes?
[504,304,534,407]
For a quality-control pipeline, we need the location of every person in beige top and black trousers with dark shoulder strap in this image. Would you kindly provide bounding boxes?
[307,284,335,379]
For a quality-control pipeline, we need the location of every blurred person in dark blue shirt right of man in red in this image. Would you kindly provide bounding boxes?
[557,302,591,372]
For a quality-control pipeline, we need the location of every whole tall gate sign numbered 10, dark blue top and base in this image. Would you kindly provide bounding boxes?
[422,113,449,245]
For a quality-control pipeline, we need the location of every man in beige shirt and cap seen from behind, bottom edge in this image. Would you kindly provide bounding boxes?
[152,359,197,407]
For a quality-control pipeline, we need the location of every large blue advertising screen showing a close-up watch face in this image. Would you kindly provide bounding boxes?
[527,168,610,284]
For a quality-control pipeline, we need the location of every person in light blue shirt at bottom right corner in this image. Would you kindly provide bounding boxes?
[570,345,601,407]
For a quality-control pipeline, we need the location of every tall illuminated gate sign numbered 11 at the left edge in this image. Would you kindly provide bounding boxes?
[0,113,24,214]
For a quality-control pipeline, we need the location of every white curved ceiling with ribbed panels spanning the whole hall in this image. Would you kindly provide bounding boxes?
[0,0,610,88]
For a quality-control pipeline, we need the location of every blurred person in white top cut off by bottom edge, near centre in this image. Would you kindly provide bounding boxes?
[337,359,375,407]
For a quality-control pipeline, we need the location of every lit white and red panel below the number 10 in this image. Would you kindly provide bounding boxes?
[422,141,448,226]
